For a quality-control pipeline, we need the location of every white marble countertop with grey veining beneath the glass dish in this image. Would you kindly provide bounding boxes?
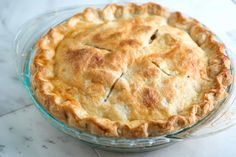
[0,0,236,157]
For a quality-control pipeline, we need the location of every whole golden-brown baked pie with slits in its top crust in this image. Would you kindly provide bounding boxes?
[31,3,233,138]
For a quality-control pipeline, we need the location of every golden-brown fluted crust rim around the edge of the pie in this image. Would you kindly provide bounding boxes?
[31,3,232,138]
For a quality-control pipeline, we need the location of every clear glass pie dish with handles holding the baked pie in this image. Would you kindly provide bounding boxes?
[15,5,236,152]
